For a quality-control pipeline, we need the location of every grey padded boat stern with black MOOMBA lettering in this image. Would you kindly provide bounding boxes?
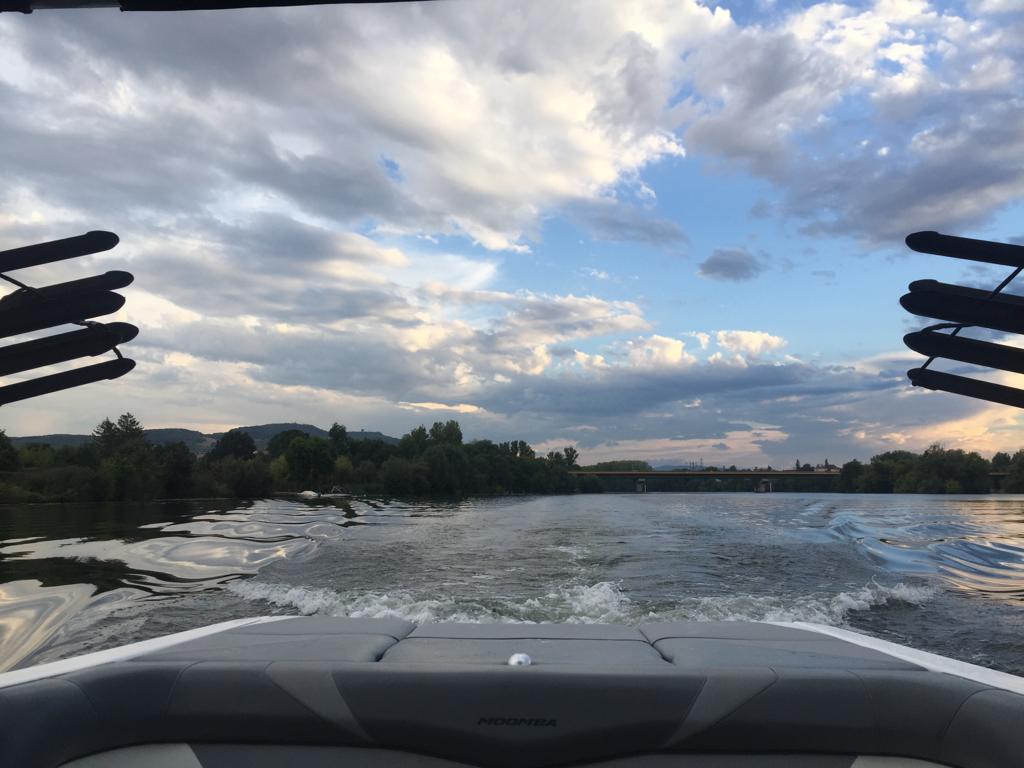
[0,616,1024,768]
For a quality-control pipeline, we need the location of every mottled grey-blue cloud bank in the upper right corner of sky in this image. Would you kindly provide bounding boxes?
[677,1,1024,240]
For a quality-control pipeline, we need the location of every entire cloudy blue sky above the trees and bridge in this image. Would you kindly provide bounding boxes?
[0,0,1024,467]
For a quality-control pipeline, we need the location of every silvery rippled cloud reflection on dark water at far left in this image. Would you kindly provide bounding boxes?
[0,501,359,672]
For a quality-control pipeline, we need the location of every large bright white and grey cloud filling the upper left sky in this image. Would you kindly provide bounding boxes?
[0,2,708,251]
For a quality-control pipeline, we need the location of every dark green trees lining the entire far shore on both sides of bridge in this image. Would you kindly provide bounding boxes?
[0,414,1024,503]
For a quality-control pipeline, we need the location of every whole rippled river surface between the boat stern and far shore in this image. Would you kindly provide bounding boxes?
[0,494,1024,674]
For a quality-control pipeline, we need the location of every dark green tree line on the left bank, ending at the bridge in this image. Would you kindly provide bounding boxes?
[0,414,600,502]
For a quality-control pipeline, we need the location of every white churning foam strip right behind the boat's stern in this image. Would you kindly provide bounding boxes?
[227,580,935,627]
